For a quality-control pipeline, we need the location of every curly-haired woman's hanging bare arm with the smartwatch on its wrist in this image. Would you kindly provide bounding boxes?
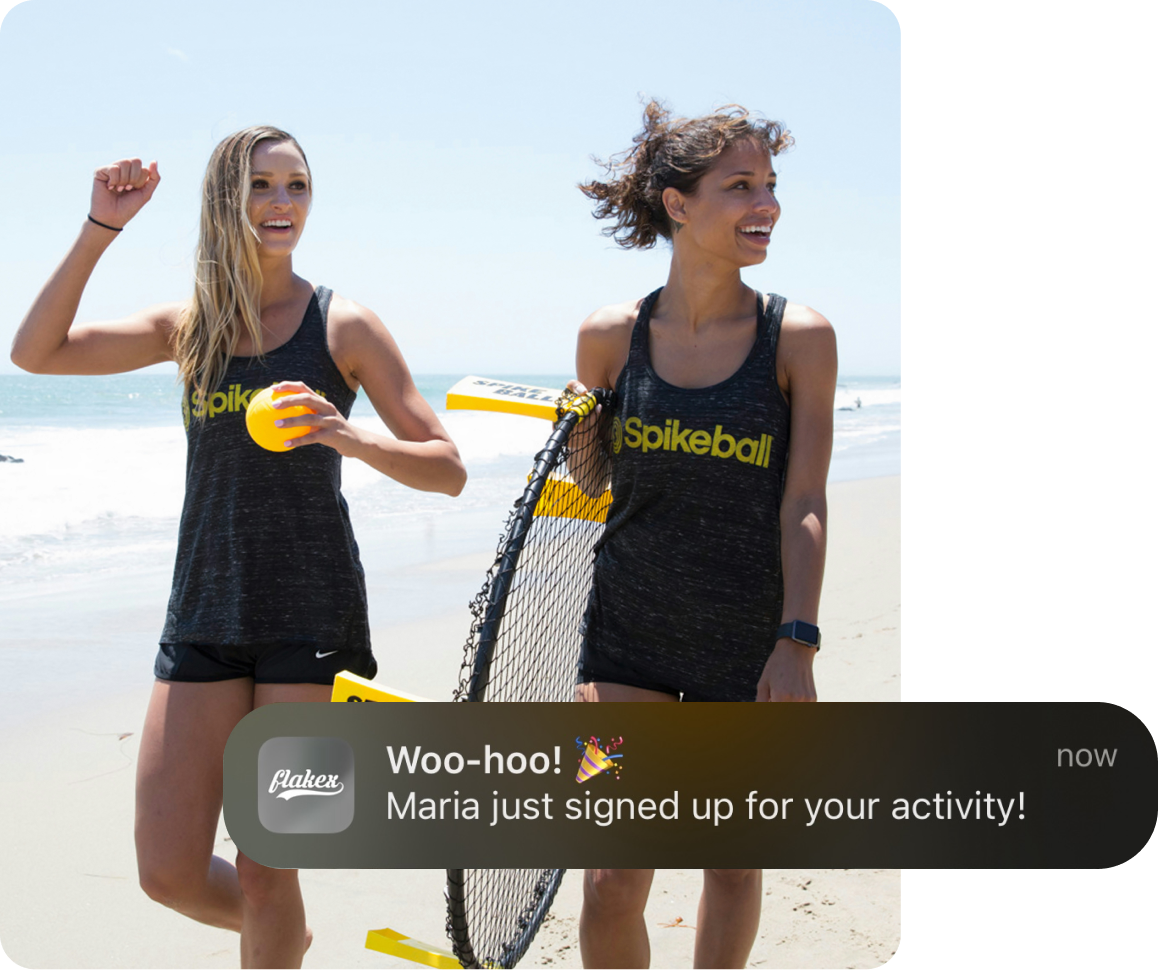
[756,303,836,700]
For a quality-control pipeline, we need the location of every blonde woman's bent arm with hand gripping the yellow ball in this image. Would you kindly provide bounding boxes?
[273,296,467,495]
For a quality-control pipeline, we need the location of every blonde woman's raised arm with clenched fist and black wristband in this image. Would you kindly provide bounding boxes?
[12,159,173,374]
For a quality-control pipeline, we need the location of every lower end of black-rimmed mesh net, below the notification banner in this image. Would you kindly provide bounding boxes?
[446,869,566,970]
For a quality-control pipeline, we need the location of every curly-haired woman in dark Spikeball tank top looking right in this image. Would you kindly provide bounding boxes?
[569,102,836,970]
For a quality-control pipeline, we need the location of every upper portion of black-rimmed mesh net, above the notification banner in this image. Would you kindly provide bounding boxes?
[454,391,611,701]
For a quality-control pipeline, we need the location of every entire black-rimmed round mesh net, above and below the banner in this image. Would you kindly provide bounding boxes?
[447,390,611,970]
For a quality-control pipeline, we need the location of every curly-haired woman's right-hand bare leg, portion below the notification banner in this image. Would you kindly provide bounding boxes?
[695,869,763,970]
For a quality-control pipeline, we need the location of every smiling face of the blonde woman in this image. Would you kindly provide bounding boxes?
[249,141,310,256]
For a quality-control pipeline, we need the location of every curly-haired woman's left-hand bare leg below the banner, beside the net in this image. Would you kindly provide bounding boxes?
[579,869,655,970]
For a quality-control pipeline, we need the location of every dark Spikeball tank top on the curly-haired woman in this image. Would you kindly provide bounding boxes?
[587,289,789,699]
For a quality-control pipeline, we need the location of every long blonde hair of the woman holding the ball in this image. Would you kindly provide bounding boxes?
[173,125,314,409]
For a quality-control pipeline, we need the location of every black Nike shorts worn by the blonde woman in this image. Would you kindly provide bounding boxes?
[153,644,378,684]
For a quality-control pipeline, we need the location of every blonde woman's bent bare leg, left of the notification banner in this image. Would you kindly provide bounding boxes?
[135,678,254,932]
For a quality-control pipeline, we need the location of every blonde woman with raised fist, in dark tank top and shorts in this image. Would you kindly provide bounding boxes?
[12,126,466,970]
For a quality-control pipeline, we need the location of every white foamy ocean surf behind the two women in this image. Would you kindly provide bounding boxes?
[0,381,901,550]
